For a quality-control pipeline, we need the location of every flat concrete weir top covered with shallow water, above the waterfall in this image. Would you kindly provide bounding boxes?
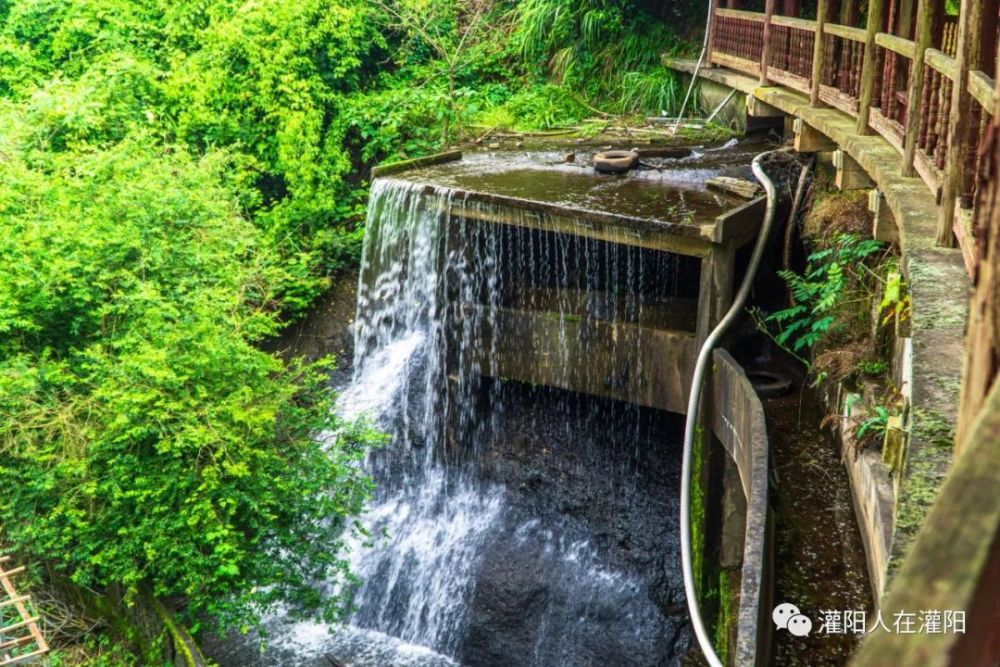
[373,145,759,257]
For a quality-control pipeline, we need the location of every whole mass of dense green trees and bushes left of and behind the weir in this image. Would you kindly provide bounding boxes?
[0,0,700,652]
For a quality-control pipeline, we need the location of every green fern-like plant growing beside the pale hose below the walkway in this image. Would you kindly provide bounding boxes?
[758,234,883,364]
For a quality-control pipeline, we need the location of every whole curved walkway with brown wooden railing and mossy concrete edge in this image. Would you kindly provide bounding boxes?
[667,0,1000,666]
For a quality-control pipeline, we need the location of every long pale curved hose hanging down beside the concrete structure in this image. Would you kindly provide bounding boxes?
[681,150,781,667]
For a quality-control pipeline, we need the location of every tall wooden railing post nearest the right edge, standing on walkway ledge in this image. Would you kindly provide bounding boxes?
[937,0,983,248]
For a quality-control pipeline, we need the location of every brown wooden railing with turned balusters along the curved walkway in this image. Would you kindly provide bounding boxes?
[709,0,997,272]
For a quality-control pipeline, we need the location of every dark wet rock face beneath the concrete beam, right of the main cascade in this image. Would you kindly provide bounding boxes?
[459,385,689,667]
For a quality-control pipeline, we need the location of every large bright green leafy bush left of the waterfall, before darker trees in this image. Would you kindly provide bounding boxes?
[0,128,372,627]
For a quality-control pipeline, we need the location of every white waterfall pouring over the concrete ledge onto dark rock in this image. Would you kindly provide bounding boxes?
[338,179,686,667]
